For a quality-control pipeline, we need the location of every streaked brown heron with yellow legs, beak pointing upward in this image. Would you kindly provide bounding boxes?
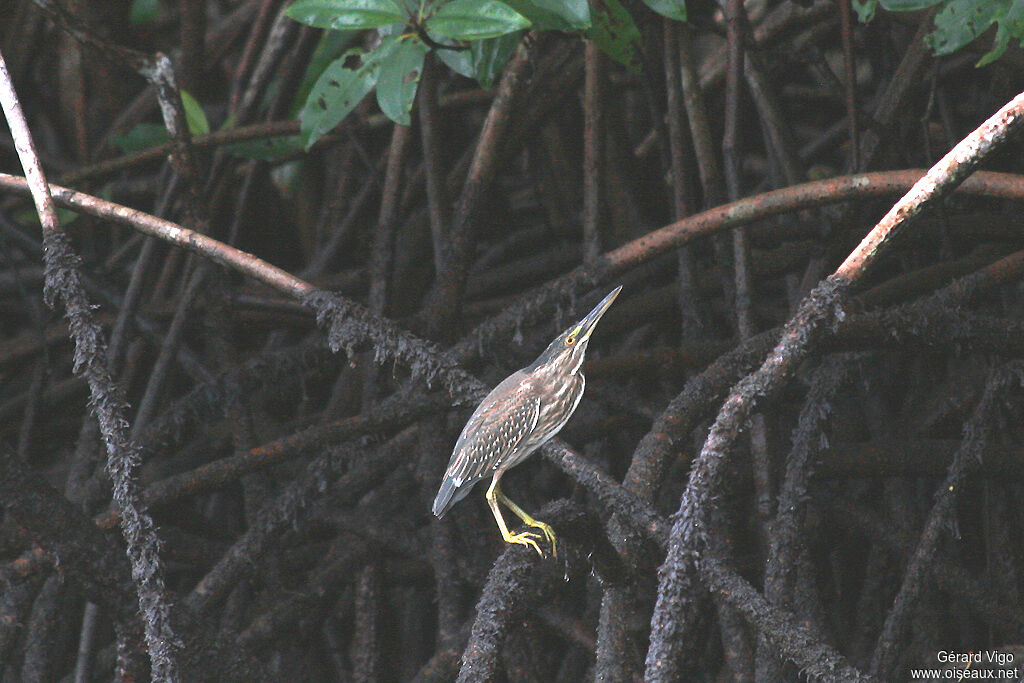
[433,286,623,558]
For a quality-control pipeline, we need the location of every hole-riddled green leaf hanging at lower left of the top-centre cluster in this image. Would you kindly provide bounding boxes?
[299,36,397,150]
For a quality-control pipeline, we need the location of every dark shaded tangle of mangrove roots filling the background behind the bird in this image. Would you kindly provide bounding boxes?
[0,0,1024,682]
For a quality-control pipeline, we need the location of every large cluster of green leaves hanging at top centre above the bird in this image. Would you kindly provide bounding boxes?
[288,0,686,147]
